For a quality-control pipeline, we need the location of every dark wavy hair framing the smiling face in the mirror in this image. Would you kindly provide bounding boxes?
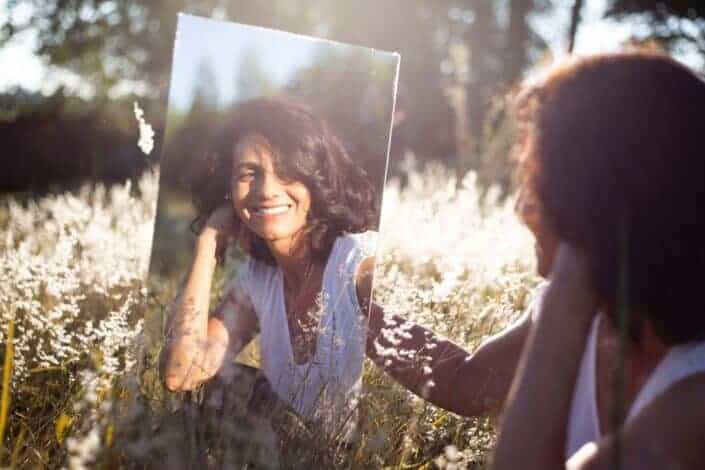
[190,97,379,265]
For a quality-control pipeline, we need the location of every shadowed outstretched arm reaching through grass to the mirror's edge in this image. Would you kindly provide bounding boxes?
[357,258,531,416]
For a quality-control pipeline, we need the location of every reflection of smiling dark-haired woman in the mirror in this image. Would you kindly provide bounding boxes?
[163,98,384,440]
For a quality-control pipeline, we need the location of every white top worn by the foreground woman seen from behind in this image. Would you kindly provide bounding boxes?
[566,315,705,459]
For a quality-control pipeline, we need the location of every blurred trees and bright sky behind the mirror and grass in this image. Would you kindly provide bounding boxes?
[0,0,705,196]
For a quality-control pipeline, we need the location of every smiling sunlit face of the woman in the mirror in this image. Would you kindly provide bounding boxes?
[231,138,311,252]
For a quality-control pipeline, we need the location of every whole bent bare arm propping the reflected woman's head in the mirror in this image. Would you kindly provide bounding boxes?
[160,209,257,391]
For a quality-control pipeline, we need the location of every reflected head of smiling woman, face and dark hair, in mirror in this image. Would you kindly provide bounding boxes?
[192,98,377,264]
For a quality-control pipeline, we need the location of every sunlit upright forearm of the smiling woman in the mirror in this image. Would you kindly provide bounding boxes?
[163,233,216,390]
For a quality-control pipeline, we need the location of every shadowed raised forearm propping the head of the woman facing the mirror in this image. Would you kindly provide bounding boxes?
[491,243,597,470]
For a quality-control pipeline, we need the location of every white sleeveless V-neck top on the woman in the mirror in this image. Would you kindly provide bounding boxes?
[231,232,377,425]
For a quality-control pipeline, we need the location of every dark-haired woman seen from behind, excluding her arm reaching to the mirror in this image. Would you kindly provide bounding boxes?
[493,53,705,469]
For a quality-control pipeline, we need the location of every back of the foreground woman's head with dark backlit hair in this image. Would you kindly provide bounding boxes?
[518,53,705,344]
